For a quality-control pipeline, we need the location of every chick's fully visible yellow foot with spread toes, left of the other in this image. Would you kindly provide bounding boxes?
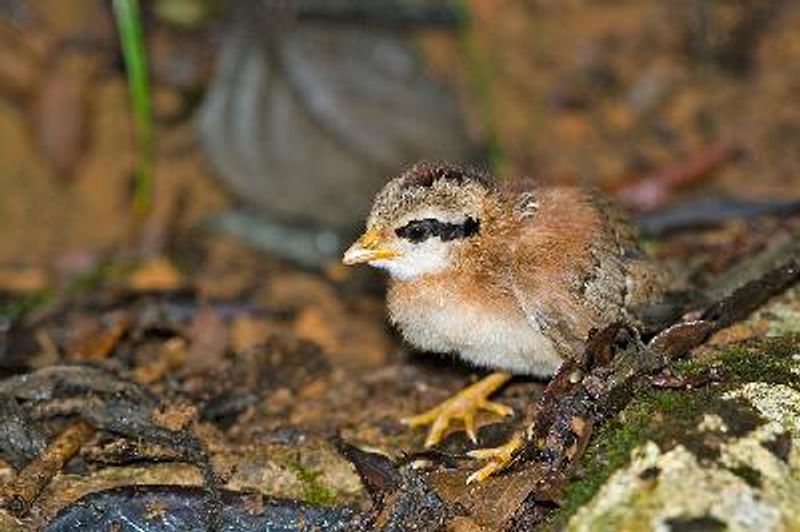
[402,372,513,447]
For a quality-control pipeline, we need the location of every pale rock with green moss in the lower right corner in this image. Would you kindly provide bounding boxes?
[548,336,800,531]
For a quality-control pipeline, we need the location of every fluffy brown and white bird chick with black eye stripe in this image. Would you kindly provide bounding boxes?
[343,162,666,479]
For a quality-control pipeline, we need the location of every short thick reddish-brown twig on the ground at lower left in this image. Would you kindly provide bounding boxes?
[2,420,95,517]
